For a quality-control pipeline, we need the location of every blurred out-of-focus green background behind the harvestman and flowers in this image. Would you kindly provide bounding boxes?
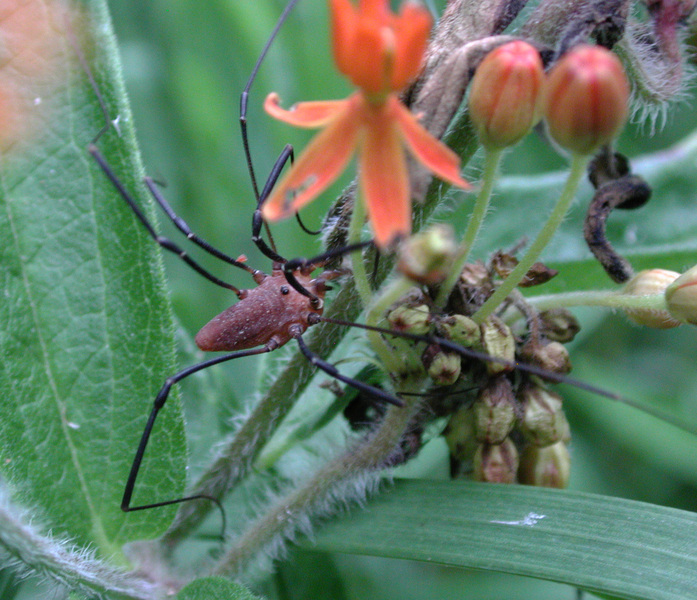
[102,0,697,600]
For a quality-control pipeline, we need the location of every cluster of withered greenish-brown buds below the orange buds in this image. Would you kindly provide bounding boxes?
[386,251,579,487]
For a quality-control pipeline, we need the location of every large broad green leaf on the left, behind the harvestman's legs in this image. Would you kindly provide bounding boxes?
[0,0,185,554]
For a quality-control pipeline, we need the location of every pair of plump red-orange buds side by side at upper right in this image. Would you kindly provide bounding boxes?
[469,40,629,154]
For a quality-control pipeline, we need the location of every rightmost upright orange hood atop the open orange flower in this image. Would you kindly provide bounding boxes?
[390,2,433,90]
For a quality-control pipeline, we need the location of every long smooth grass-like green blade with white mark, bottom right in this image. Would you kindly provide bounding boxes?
[305,480,697,600]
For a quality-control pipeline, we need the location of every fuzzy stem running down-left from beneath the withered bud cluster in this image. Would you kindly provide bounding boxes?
[213,378,423,575]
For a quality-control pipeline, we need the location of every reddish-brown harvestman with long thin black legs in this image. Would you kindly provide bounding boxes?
[83,0,696,532]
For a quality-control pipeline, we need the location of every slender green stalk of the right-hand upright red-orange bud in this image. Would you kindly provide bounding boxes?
[472,154,591,323]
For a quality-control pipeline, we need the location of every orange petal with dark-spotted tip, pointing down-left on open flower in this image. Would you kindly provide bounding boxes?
[262,94,361,221]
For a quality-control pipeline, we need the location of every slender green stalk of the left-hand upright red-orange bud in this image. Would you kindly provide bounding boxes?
[436,144,503,308]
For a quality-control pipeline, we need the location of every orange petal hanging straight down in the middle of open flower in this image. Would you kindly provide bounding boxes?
[359,103,411,248]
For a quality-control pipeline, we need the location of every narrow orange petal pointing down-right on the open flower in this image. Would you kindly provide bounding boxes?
[387,95,472,190]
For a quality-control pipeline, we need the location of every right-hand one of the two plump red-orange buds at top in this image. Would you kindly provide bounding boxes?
[544,46,629,154]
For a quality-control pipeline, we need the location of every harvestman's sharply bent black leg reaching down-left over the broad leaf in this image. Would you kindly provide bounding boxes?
[121,343,277,512]
